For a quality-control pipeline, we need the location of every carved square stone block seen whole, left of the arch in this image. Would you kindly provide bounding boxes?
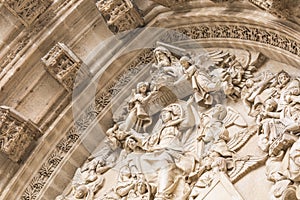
[42,42,90,92]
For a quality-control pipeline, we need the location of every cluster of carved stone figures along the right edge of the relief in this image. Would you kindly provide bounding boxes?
[239,68,300,199]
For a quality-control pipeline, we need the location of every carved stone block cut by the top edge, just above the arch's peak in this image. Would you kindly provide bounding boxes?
[96,0,144,33]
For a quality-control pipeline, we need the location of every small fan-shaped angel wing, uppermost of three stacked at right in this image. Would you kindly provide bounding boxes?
[223,107,248,128]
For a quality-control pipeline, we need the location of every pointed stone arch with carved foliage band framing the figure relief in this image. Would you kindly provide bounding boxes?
[2,1,299,199]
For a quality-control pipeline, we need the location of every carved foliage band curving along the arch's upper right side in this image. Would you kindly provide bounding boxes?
[161,24,300,57]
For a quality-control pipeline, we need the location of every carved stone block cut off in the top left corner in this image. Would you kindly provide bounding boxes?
[2,0,52,26]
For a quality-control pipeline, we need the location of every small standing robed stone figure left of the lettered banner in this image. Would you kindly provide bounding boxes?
[122,82,157,132]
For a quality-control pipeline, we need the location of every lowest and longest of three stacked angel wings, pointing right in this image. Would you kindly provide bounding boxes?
[228,154,268,183]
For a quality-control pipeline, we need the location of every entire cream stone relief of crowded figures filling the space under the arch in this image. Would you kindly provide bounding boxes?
[52,46,294,200]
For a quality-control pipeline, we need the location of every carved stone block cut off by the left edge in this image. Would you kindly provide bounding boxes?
[0,106,42,162]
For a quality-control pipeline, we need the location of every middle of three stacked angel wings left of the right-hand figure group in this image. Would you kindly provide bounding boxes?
[227,126,257,151]
